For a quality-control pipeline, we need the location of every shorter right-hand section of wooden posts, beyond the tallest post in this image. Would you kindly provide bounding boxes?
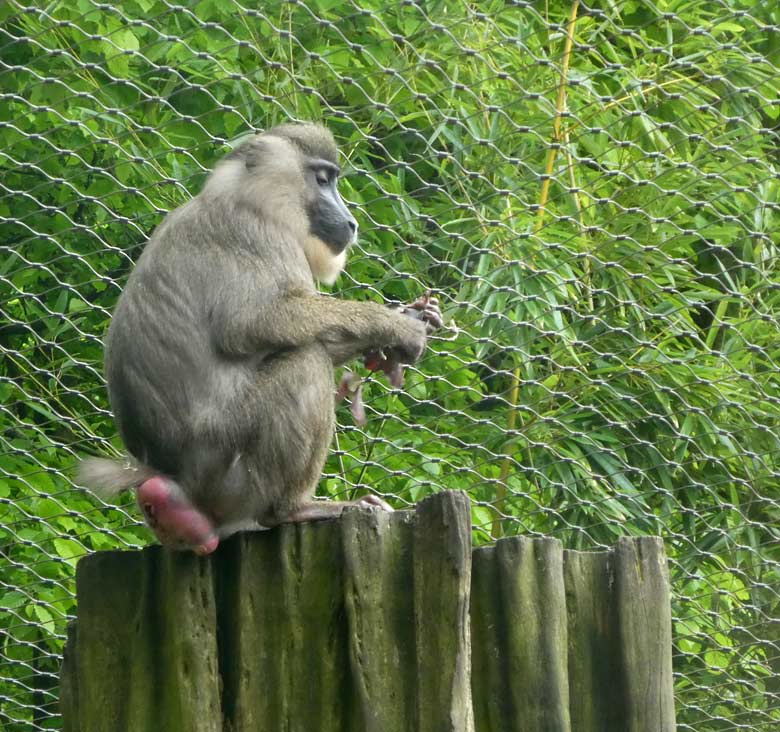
[471,537,675,732]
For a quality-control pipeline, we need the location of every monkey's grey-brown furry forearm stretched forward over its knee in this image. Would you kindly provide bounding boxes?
[212,294,426,365]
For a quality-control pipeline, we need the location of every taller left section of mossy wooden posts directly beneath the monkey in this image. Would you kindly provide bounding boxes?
[62,492,473,732]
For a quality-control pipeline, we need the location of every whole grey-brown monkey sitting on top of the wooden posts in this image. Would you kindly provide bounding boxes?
[78,123,441,554]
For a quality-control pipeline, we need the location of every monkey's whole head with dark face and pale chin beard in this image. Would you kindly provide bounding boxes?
[204,123,358,284]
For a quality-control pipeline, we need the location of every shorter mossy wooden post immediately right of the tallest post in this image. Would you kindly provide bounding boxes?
[471,537,571,732]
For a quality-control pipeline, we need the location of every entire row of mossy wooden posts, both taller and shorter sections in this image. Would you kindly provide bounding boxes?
[61,492,674,732]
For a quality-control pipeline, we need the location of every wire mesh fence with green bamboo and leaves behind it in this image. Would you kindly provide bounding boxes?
[0,0,780,732]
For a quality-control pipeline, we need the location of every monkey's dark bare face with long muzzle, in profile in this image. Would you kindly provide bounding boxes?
[304,159,358,257]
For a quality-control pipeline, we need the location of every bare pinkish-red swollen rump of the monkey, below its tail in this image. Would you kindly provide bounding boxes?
[136,475,219,556]
